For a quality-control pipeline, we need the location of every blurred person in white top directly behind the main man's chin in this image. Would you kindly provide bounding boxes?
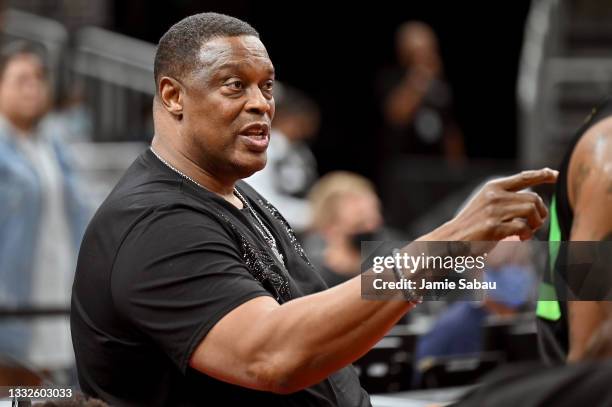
[246,85,320,232]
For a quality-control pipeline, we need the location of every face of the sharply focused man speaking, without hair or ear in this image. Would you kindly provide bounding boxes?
[181,36,274,178]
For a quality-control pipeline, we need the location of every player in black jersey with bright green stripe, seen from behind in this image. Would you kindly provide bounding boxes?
[537,97,612,364]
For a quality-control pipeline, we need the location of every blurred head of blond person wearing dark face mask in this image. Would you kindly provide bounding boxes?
[304,172,383,287]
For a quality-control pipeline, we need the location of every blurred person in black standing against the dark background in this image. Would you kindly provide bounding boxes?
[378,21,464,162]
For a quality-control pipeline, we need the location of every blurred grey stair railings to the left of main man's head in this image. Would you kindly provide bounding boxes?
[2,9,155,145]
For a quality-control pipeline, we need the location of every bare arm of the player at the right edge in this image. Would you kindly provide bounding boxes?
[568,119,612,361]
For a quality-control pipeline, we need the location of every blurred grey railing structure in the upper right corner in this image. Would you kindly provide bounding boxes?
[518,0,612,167]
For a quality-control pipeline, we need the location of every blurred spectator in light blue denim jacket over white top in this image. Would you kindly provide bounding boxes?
[0,42,88,369]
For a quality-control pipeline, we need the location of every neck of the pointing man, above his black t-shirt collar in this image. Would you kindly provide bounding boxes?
[151,135,243,209]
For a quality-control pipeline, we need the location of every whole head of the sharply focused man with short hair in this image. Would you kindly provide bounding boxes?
[154,13,274,179]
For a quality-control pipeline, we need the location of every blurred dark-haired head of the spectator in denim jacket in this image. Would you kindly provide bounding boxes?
[0,42,50,130]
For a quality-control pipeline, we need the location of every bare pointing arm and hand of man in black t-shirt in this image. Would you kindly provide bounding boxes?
[190,169,556,393]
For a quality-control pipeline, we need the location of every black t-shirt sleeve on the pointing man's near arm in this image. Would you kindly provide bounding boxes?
[111,208,271,372]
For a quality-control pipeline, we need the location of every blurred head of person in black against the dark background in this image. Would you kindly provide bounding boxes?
[395,21,440,71]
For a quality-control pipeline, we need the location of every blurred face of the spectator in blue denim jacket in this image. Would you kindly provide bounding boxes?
[0,54,49,125]
